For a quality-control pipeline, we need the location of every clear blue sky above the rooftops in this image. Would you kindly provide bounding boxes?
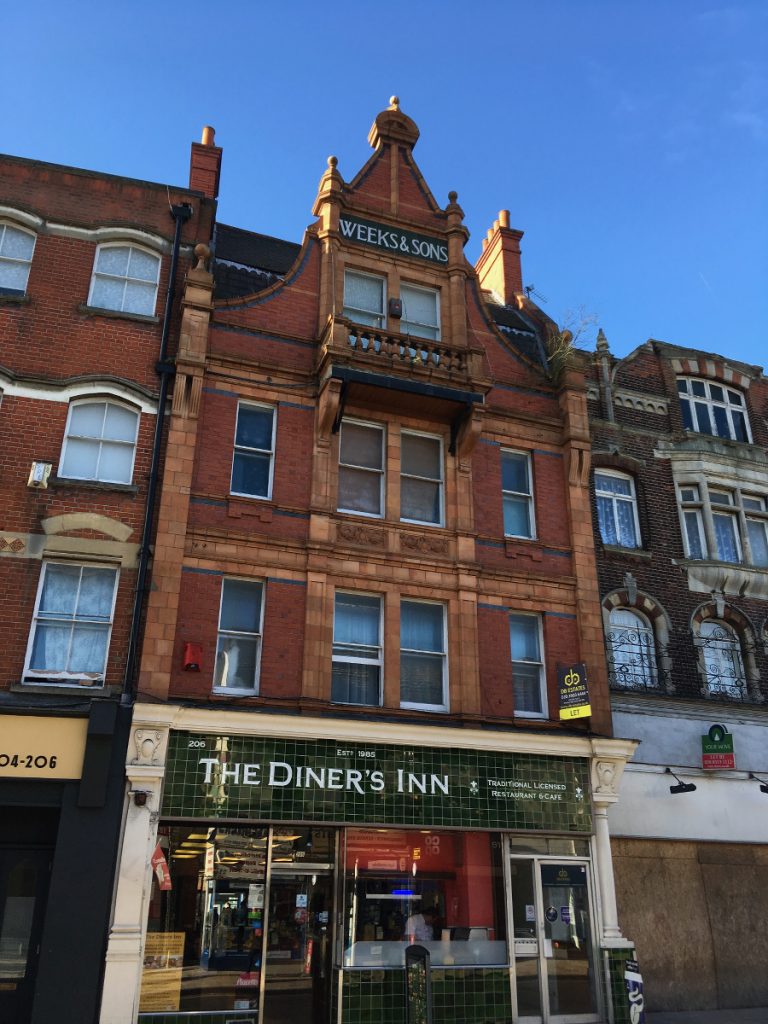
[0,0,768,365]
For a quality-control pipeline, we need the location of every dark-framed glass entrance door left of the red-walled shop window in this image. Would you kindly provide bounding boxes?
[263,865,333,1024]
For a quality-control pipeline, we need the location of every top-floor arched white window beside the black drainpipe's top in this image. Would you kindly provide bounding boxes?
[88,245,160,316]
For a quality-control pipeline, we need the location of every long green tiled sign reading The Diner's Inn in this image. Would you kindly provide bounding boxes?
[163,731,592,833]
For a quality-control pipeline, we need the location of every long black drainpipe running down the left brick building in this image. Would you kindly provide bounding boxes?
[120,203,193,707]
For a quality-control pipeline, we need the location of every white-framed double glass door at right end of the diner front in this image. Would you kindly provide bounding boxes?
[510,857,599,1024]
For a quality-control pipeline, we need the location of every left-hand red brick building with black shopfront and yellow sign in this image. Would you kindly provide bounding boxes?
[0,148,213,1024]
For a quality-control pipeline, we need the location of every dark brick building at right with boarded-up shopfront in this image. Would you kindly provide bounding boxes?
[589,334,768,1010]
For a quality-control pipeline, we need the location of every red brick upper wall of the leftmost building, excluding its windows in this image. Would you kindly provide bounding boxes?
[0,151,213,695]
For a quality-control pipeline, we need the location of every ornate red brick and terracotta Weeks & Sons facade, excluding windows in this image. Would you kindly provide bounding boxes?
[138,101,610,735]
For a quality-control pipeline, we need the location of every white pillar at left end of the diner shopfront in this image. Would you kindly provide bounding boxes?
[99,727,168,1024]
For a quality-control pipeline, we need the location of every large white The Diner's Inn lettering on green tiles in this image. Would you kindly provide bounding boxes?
[200,758,449,796]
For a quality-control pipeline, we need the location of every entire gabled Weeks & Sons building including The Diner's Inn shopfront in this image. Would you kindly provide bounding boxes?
[101,99,634,1024]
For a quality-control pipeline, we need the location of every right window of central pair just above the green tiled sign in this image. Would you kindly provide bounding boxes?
[400,601,447,711]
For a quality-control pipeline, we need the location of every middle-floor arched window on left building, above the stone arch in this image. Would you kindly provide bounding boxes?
[58,401,139,483]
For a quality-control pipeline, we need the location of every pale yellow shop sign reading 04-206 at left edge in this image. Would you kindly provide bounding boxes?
[0,715,88,779]
